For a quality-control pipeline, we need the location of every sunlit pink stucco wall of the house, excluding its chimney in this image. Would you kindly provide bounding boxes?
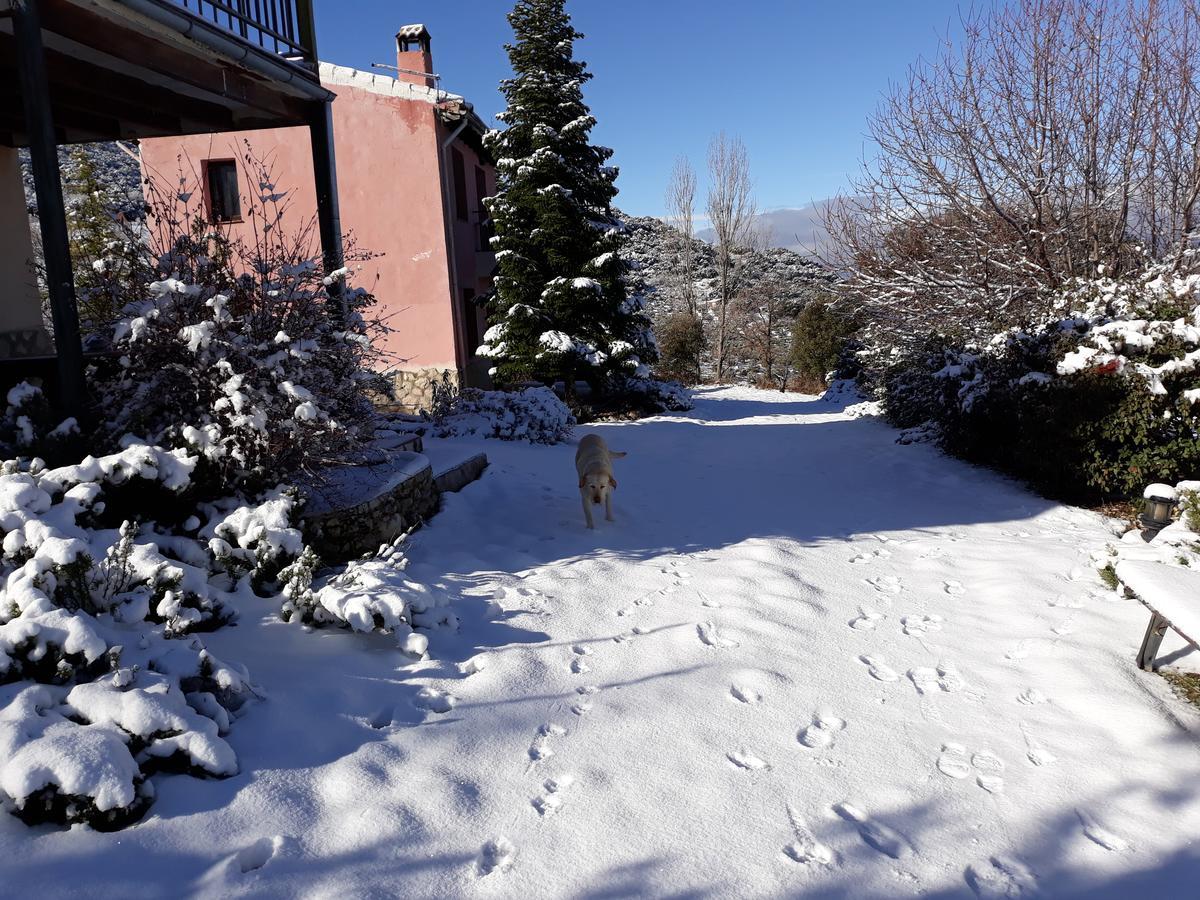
[142,65,492,408]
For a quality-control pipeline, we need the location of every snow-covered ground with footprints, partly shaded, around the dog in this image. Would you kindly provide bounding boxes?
[0,389,1200,898]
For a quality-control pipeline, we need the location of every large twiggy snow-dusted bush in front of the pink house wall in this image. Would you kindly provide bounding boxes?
[95,152,382,497]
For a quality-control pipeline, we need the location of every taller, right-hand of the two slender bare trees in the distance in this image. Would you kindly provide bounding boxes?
[707,131,755,383]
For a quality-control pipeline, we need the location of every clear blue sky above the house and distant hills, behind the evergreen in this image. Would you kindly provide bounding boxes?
[316,0,968,215]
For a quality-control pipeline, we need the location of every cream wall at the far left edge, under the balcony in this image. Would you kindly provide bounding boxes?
[0,146,50,359]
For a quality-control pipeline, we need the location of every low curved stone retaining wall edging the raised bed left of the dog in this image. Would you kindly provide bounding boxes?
[304,466,438,563]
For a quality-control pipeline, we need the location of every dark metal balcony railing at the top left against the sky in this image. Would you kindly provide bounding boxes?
[173,0,317,71]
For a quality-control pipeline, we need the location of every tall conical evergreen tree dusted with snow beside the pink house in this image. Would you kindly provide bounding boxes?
[479,0,656,395]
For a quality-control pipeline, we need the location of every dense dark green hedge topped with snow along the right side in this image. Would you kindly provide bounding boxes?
[869,258,1200,502]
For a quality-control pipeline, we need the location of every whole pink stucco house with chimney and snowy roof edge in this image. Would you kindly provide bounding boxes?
[142,25,496,408]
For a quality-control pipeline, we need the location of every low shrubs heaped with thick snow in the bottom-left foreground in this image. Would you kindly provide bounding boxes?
[0,442,258,828]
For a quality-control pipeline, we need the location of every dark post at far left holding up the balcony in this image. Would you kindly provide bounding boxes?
[12,0,85,418]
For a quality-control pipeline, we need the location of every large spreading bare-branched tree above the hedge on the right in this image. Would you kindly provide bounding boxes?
[826,0,1200,355]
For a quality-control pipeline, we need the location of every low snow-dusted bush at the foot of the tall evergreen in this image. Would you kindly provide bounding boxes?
[433,388,575,444]
